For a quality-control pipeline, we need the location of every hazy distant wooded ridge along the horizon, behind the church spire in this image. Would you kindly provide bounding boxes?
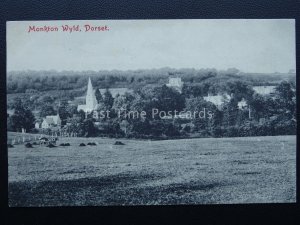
[7,68,295,94]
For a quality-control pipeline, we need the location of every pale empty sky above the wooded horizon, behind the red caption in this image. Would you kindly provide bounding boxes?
[6,19,296,73]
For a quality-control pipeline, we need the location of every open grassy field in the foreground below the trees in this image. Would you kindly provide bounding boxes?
[8,136,296,206]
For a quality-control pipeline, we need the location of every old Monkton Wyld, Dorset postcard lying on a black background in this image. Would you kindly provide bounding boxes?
[6,19,297,207]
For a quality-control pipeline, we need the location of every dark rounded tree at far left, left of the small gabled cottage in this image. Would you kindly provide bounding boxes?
[10,98,35,131]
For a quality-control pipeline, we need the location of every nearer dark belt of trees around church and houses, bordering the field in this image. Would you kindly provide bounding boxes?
[8,79,296,139]
